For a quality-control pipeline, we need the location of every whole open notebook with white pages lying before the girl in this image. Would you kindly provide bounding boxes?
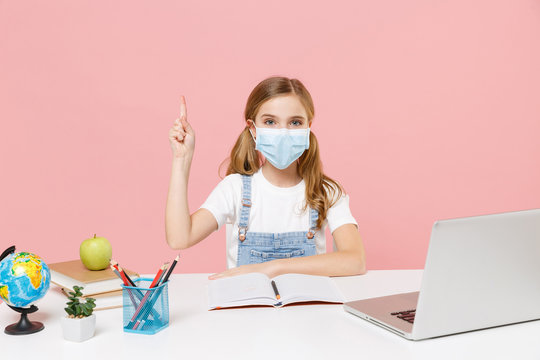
[208,273,344,310]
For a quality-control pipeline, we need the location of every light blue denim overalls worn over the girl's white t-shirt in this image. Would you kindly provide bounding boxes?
[236,175,319,266]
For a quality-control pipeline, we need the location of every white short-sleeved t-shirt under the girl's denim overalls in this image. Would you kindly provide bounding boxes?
[201,168,358,268]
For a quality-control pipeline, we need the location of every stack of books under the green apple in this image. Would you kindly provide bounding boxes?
[49,260,139,310]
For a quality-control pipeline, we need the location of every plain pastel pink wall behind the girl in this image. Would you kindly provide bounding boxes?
[0,0,540,272]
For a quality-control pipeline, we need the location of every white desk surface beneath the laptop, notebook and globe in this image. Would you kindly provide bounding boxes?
[0,270,540,360]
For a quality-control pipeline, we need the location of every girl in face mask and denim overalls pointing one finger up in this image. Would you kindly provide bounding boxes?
[165,77,366,279]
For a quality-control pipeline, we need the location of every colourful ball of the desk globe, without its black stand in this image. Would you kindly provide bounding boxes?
[0,252,51,307]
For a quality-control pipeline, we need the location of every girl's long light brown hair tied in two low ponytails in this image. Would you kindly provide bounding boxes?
[221,76,344,229]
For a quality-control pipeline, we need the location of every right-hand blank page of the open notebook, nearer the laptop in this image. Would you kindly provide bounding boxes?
[273,274,344,304]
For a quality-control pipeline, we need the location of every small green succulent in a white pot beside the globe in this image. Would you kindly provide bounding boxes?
[60,286,96,342]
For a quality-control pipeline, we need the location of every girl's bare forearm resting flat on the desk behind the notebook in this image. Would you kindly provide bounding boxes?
[209,224,366,279]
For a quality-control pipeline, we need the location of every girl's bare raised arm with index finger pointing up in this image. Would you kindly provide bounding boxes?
[165,96,217,249]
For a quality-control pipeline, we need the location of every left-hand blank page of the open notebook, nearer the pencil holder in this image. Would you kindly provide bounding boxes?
[208,273,277,309]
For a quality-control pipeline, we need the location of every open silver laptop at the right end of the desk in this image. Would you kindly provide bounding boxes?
[343,209,540,340]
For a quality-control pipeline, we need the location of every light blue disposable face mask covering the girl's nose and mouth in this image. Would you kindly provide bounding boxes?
[250,127,309,170]
